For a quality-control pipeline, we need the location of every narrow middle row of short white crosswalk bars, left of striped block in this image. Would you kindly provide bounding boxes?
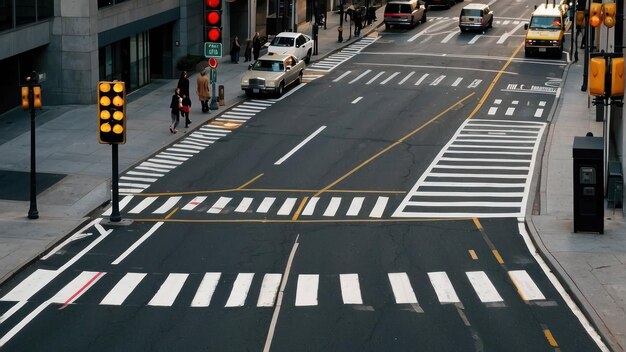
[103,192,402,219]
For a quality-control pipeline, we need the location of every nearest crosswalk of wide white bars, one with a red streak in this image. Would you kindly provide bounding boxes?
[0,269,546,314]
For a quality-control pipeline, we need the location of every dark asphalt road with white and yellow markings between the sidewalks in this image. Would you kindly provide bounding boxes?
[0,2,598,351]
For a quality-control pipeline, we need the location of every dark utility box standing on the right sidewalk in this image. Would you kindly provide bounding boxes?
[572,137,604,233]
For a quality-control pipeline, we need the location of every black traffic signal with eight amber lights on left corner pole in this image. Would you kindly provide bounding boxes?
[98,82,126,144]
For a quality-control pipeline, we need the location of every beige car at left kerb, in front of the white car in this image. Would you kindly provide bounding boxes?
[241,54,306,97]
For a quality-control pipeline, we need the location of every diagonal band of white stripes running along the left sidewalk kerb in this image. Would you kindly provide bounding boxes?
[113,99,276,197]
